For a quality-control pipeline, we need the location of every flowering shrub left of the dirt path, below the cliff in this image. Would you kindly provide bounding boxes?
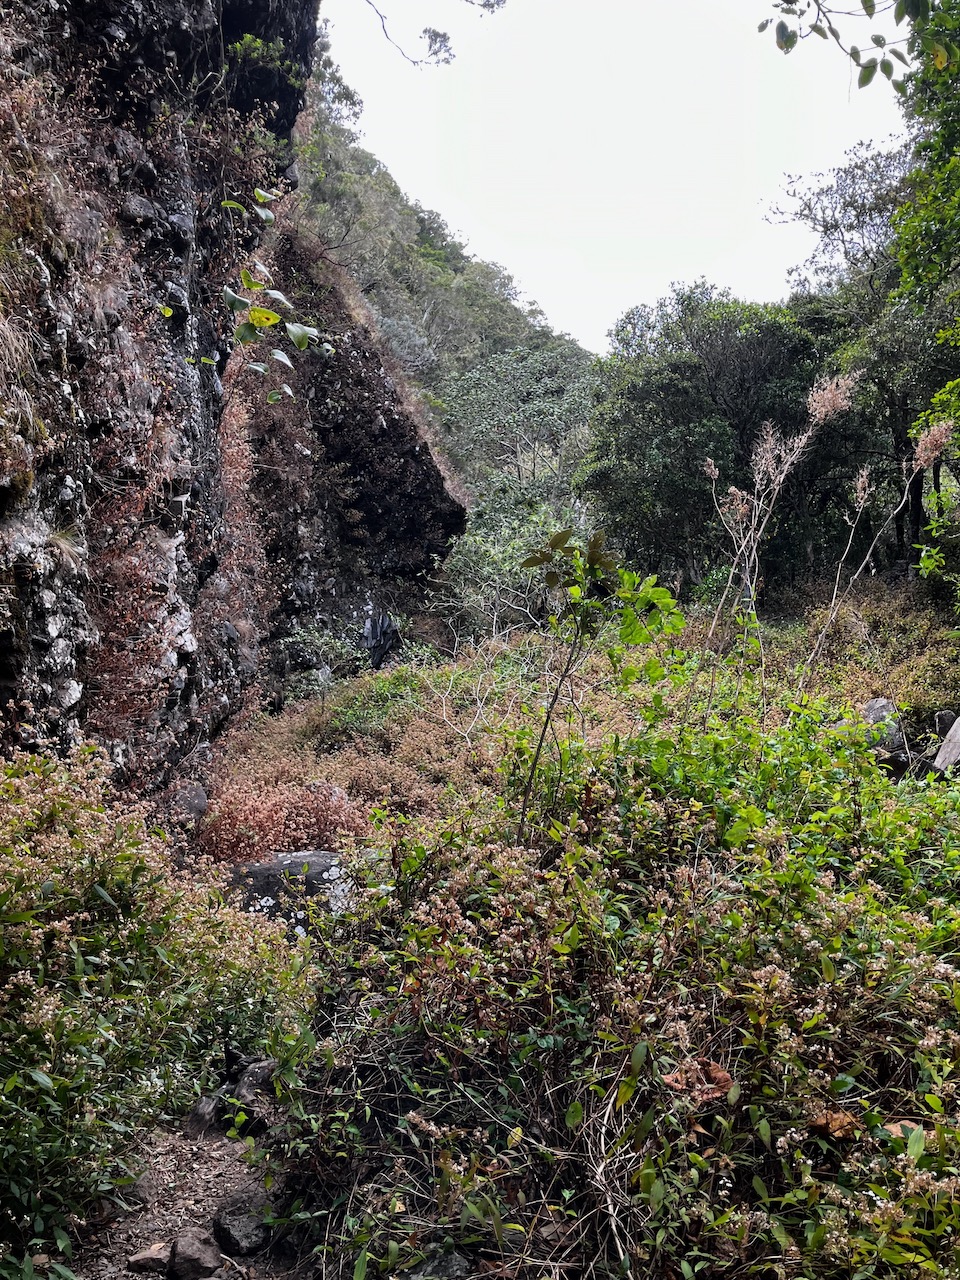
[0,750,316,1277]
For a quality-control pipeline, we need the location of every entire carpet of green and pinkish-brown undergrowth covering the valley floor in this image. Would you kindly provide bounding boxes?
[9,581,960,1280]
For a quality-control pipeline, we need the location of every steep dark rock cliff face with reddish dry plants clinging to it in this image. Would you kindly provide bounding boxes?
[0,0,462,785]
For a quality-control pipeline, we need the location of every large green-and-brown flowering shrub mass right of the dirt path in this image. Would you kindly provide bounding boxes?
[268,655,960,1280]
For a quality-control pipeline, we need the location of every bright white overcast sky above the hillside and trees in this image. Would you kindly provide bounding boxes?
[321,0,900,351]
